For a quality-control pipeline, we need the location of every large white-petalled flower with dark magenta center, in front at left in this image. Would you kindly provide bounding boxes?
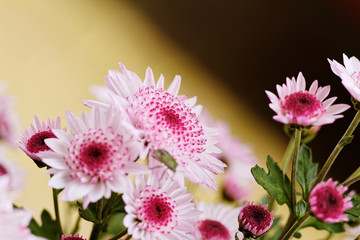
[39,107,147,208]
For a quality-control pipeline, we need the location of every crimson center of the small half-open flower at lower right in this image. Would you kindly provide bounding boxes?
[312,186,344,218]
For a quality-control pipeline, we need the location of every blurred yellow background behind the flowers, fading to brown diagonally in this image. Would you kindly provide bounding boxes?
[0,0,340,239]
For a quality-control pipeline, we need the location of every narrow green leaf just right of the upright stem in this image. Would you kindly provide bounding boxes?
[296,145,318,200]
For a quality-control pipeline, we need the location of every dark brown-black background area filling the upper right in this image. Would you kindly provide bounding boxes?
[134,0,360,190]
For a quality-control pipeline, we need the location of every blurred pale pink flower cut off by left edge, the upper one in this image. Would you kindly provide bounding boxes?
[0,83,18,144]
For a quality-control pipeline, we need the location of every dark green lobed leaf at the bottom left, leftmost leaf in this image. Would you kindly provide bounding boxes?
[29,209,61,240]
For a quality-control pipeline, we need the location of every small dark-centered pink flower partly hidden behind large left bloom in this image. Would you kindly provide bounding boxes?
[18,116,65,166]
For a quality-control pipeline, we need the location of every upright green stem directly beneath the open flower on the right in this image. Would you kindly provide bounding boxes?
[291,128,302,210]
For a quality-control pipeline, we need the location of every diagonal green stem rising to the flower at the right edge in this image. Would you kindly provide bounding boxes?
[314,111,360,185]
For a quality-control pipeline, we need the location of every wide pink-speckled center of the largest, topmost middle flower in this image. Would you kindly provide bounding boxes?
[129,86,206,165]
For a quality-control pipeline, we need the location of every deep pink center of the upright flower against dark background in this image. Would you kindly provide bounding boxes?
[281,91,324,117]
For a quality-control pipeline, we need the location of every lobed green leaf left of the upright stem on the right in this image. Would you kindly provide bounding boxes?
[251,156,290,208]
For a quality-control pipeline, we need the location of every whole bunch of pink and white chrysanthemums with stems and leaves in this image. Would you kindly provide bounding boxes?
[0,54,360,240]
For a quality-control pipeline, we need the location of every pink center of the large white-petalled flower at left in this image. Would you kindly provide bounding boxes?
[65,128,131,180]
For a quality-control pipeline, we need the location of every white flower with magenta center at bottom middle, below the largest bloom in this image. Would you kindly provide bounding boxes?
[123,173,201,240]
